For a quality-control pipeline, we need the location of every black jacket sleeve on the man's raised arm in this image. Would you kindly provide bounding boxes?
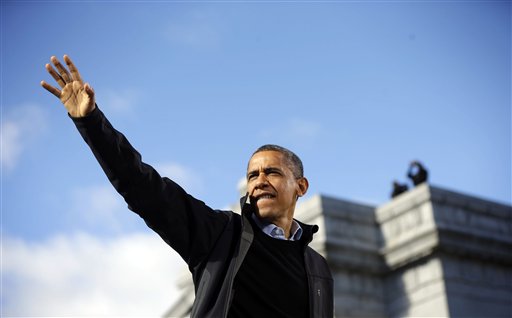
[72,107,228,268]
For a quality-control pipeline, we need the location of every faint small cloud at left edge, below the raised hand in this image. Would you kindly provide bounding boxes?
[1,105,47,170]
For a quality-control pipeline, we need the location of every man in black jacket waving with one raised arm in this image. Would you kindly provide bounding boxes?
[41,56,333,317]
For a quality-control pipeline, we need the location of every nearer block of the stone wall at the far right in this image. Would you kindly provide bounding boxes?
[376,184,512,317]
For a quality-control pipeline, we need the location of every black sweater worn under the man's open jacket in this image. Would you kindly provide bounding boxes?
[228,220,309,318]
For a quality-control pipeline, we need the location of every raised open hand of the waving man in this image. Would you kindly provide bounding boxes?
[41,55,96,117]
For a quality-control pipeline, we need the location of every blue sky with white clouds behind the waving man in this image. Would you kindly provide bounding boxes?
[1,1,512,315]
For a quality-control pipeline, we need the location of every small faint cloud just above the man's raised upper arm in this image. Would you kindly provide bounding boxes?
[155,162,203,195]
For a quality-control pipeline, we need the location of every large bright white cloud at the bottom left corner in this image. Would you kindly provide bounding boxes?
[1,233,185,316]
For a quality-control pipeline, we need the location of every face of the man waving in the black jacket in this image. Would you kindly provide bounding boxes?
[247,151,308,226]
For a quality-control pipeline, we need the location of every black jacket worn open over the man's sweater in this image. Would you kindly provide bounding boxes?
[73,107,333,317]
